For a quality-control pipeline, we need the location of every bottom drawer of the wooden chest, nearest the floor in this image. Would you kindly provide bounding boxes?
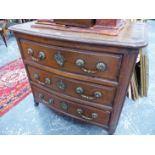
[32,86,110,127]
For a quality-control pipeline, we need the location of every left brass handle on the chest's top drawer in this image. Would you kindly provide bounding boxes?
[27,48,46,62]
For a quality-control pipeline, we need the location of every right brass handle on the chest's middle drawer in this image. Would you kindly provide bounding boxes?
[76,87,102,100]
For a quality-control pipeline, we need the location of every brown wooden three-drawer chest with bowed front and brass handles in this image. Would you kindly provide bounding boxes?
[10,22,147,134]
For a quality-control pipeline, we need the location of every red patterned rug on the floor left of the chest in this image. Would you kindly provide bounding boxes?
[0,59,31,116]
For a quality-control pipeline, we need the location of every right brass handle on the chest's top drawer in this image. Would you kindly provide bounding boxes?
[75,59,107,74]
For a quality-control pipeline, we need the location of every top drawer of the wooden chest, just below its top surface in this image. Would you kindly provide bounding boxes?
[21,40,122,81]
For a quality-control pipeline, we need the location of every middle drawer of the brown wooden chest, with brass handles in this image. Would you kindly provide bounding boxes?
[27,66,116,106]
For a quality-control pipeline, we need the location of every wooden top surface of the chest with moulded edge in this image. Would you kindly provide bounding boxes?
[9,22,147,48]
